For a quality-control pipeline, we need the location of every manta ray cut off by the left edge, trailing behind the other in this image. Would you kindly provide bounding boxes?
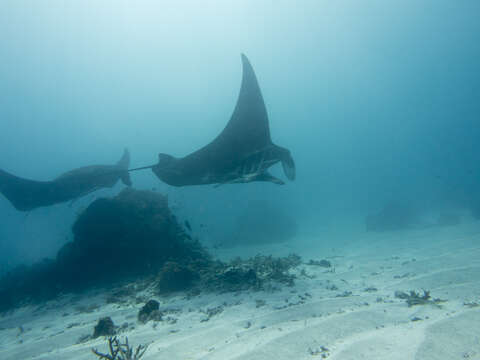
[0,149,132,211]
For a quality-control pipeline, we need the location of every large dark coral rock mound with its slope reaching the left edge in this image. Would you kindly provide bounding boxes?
[0,188,211,312]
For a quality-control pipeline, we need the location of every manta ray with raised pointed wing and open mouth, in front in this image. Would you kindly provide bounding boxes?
[143,54,295,186]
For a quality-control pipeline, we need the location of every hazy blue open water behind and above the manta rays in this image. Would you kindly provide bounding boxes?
[0,0,480,269]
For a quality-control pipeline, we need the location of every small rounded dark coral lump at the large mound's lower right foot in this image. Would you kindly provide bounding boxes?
[158,261,197,293]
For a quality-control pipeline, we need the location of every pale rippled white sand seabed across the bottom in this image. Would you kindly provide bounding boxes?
[0,222,480,360]
